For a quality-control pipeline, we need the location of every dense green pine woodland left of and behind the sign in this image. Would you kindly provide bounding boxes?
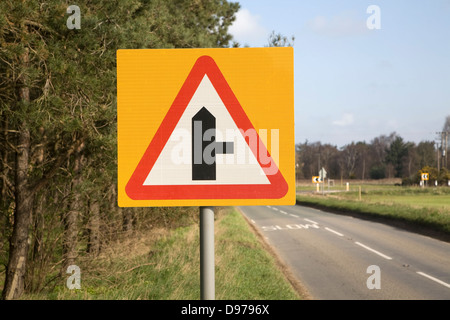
[0,0,243,299]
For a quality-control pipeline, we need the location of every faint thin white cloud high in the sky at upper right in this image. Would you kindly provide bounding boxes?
[306,12,369,37]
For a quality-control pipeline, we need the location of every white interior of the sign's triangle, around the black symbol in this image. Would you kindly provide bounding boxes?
[144,75,270,185]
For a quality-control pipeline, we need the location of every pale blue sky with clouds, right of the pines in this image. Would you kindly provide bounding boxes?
[229,0,450,147]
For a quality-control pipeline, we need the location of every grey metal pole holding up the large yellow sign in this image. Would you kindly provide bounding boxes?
[200,207,215,300]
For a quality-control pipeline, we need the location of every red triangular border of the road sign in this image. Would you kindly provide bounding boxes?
[125,56,288,200]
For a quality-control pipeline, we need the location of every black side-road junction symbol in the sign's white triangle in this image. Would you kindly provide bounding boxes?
[192,107,234,180]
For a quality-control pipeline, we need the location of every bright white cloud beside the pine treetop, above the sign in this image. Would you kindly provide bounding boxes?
[228,8,269,46]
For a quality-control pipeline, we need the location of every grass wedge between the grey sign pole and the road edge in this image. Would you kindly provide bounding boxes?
[216,211,299,300]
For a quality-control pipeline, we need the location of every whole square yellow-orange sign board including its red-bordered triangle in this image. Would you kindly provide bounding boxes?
[117,48,295,207]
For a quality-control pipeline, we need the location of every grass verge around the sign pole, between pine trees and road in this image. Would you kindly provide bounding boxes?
[23,209,301,300]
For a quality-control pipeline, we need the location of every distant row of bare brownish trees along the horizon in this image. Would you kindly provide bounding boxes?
[296,122,450,185]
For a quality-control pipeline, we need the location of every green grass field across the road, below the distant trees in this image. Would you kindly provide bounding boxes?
[297,185,450,234]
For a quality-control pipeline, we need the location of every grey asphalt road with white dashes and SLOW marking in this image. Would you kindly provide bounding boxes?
[239,205,450,300]
